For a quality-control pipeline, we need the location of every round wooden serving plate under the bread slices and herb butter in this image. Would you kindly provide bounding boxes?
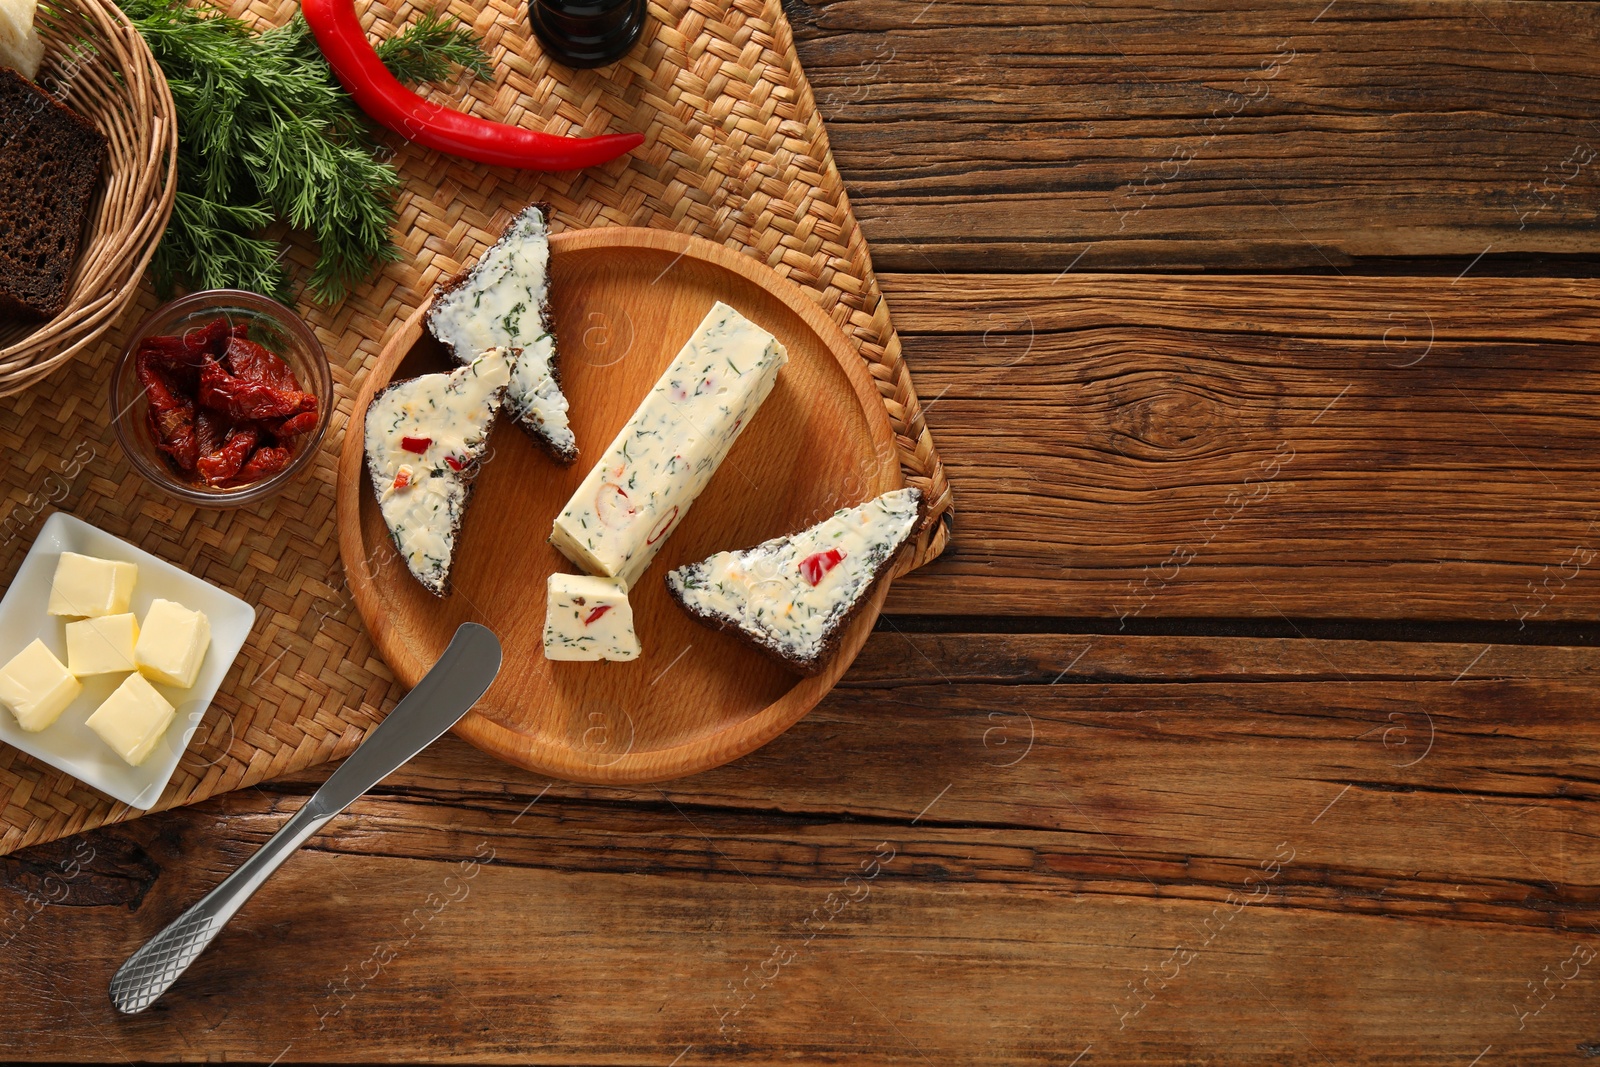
[339,227,902,784]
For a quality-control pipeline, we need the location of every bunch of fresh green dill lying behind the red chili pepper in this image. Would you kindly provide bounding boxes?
[122,0,488,304]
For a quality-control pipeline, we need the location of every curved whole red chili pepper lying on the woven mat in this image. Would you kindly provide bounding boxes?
[301,0,645,171]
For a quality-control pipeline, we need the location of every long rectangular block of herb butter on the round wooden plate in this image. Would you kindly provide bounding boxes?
[550,301,789,587]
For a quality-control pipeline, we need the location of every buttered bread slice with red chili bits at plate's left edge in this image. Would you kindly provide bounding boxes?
[365,349,515,597]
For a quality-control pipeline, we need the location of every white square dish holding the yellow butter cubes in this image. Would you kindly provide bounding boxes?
[0,512,256,808]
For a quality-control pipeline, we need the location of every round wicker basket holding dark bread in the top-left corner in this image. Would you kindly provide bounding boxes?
[0,0,178,397]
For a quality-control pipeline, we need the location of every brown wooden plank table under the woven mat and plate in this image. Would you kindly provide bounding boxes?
[0,0,1600,1067]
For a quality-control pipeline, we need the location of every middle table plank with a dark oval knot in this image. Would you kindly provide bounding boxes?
[885,274,1600,627]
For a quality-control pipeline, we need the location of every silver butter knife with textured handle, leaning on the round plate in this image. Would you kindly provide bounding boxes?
[110,622,501,1014]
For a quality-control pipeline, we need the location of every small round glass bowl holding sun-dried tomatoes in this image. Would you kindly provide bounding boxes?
[110,290,333,507]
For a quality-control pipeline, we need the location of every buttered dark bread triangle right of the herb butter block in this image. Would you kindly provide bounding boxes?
[667,490,922,675]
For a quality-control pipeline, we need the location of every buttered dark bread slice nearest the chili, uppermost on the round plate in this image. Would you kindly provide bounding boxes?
[427,203,578,464]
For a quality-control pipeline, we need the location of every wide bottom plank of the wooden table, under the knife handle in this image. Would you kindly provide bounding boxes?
[0,629,1600,1067]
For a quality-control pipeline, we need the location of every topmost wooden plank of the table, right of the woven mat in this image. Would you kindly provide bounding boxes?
[786,0,1600,275]
